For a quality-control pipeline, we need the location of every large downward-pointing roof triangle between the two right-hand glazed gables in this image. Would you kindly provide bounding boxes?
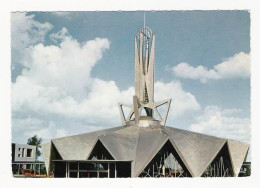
[164,127,226,177]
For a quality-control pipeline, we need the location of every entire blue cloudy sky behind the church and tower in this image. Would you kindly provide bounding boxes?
[11,10,251,152]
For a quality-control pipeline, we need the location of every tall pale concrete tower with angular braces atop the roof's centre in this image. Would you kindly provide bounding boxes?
[119,27,171,126]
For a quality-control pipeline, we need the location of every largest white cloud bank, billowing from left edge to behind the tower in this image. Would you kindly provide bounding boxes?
[11,15,200,142]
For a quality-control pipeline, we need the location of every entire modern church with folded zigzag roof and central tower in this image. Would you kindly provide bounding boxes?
[43,27,249,178]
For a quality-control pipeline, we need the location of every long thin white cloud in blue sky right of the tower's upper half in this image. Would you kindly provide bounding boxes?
[170,52,250,83]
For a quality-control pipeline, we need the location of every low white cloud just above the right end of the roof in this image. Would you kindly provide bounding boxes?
[190,106,251,142]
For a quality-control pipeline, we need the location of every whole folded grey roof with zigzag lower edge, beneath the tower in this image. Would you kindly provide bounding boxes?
[43,125,248,177]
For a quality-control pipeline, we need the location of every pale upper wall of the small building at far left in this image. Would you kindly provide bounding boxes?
[12,144,36,162]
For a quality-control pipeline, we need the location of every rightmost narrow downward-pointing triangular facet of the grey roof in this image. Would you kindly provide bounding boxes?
[228,140,249,176]
